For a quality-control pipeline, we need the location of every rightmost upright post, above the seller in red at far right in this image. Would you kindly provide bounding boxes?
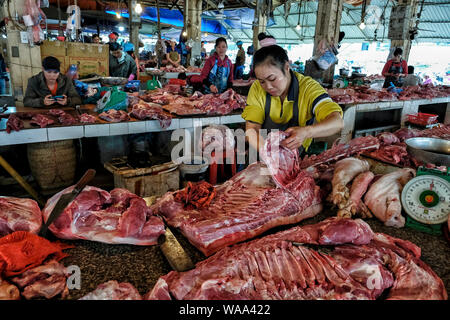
[388,0,418,61]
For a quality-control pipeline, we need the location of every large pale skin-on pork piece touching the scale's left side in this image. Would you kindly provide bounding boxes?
[364,168,416,228]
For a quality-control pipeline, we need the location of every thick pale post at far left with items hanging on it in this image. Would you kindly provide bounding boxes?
[1,1,42,106]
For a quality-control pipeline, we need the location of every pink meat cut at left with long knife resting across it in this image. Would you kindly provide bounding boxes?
[42,186,164,245]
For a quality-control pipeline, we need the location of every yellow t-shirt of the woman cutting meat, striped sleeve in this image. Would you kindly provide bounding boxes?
[242,71,343,150]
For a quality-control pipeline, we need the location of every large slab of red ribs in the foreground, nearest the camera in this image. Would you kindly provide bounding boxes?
[148,218,447,300]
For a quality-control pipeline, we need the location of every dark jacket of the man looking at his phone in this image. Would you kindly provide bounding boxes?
[23,71,81,108]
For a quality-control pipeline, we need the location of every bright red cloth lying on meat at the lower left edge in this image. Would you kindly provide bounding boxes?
[0,231,74,277]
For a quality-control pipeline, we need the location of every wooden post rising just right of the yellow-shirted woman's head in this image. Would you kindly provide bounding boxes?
[313,0,343,83]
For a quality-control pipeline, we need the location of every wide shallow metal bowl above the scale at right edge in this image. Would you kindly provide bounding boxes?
[405,137,450,167]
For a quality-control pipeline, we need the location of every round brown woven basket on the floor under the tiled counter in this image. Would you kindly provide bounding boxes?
[27,140,76,189]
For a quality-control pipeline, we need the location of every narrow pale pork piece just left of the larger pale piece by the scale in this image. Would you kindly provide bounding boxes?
[330,158,370,209]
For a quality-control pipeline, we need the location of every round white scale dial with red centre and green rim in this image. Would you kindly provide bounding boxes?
[402,175,450,224]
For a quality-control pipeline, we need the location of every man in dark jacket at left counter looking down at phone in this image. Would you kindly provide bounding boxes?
[23,56,81,108]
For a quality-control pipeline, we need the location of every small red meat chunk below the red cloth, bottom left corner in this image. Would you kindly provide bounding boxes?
[11,260,69,299]
